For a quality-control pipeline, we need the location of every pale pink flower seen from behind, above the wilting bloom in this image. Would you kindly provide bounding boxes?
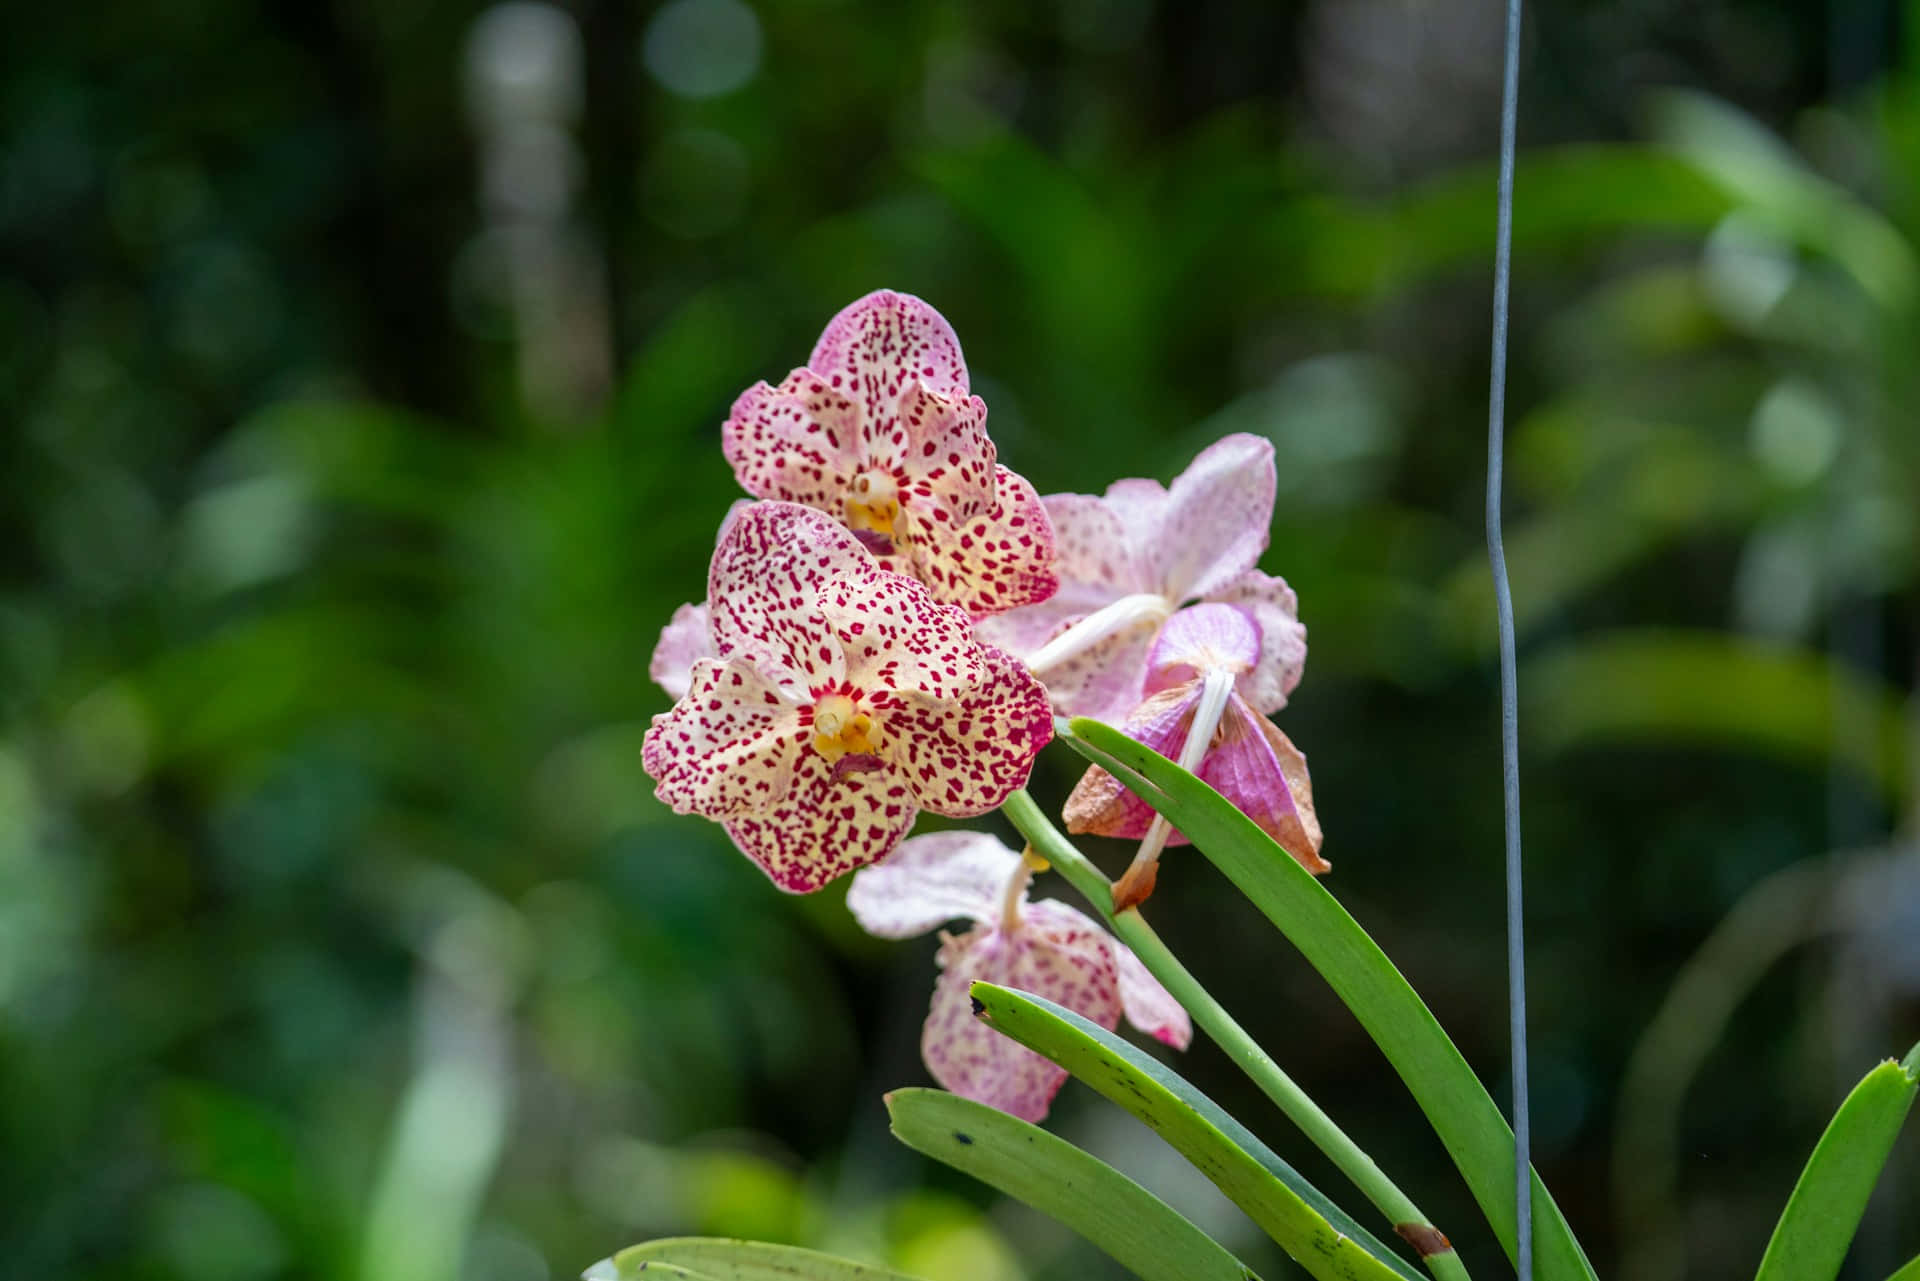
[979,434,1308,724]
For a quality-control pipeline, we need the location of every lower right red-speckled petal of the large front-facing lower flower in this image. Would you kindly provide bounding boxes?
[874,645,1054,818]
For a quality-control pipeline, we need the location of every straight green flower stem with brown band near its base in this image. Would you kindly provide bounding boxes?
[1002,789,1469,1281]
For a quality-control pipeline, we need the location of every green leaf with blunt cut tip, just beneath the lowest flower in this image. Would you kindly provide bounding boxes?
[887,1089,1258,1281]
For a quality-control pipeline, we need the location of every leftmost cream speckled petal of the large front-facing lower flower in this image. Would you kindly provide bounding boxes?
[641,655,806,818]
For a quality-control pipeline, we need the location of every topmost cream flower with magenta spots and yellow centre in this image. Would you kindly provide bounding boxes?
[722,290,1054,618]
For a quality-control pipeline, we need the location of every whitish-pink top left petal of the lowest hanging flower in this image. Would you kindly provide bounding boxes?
[847,832,1020,939]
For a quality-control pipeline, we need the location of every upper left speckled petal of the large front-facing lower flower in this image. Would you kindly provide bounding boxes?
[707,503,864,689]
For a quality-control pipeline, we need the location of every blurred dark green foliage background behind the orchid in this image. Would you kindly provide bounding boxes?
[0,0,1920,1281]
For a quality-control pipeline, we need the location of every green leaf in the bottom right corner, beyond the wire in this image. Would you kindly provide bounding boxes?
[1755,1045,1920,1281]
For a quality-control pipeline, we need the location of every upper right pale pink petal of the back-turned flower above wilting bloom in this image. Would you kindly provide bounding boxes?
[1136,432,1275,601]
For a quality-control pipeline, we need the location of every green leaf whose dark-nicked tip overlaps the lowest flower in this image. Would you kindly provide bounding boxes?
[973,981,1425,1281]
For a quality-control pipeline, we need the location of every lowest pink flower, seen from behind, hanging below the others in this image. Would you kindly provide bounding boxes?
[847,832,1192,1122]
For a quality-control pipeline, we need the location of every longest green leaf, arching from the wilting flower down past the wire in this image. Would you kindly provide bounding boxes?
[1066,720,1594,1281]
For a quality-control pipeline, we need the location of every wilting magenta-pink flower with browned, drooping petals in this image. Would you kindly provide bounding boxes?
[1066,603,1332,908]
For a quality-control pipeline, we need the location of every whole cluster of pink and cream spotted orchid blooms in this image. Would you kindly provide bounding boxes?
[643,290,1327,1120]
